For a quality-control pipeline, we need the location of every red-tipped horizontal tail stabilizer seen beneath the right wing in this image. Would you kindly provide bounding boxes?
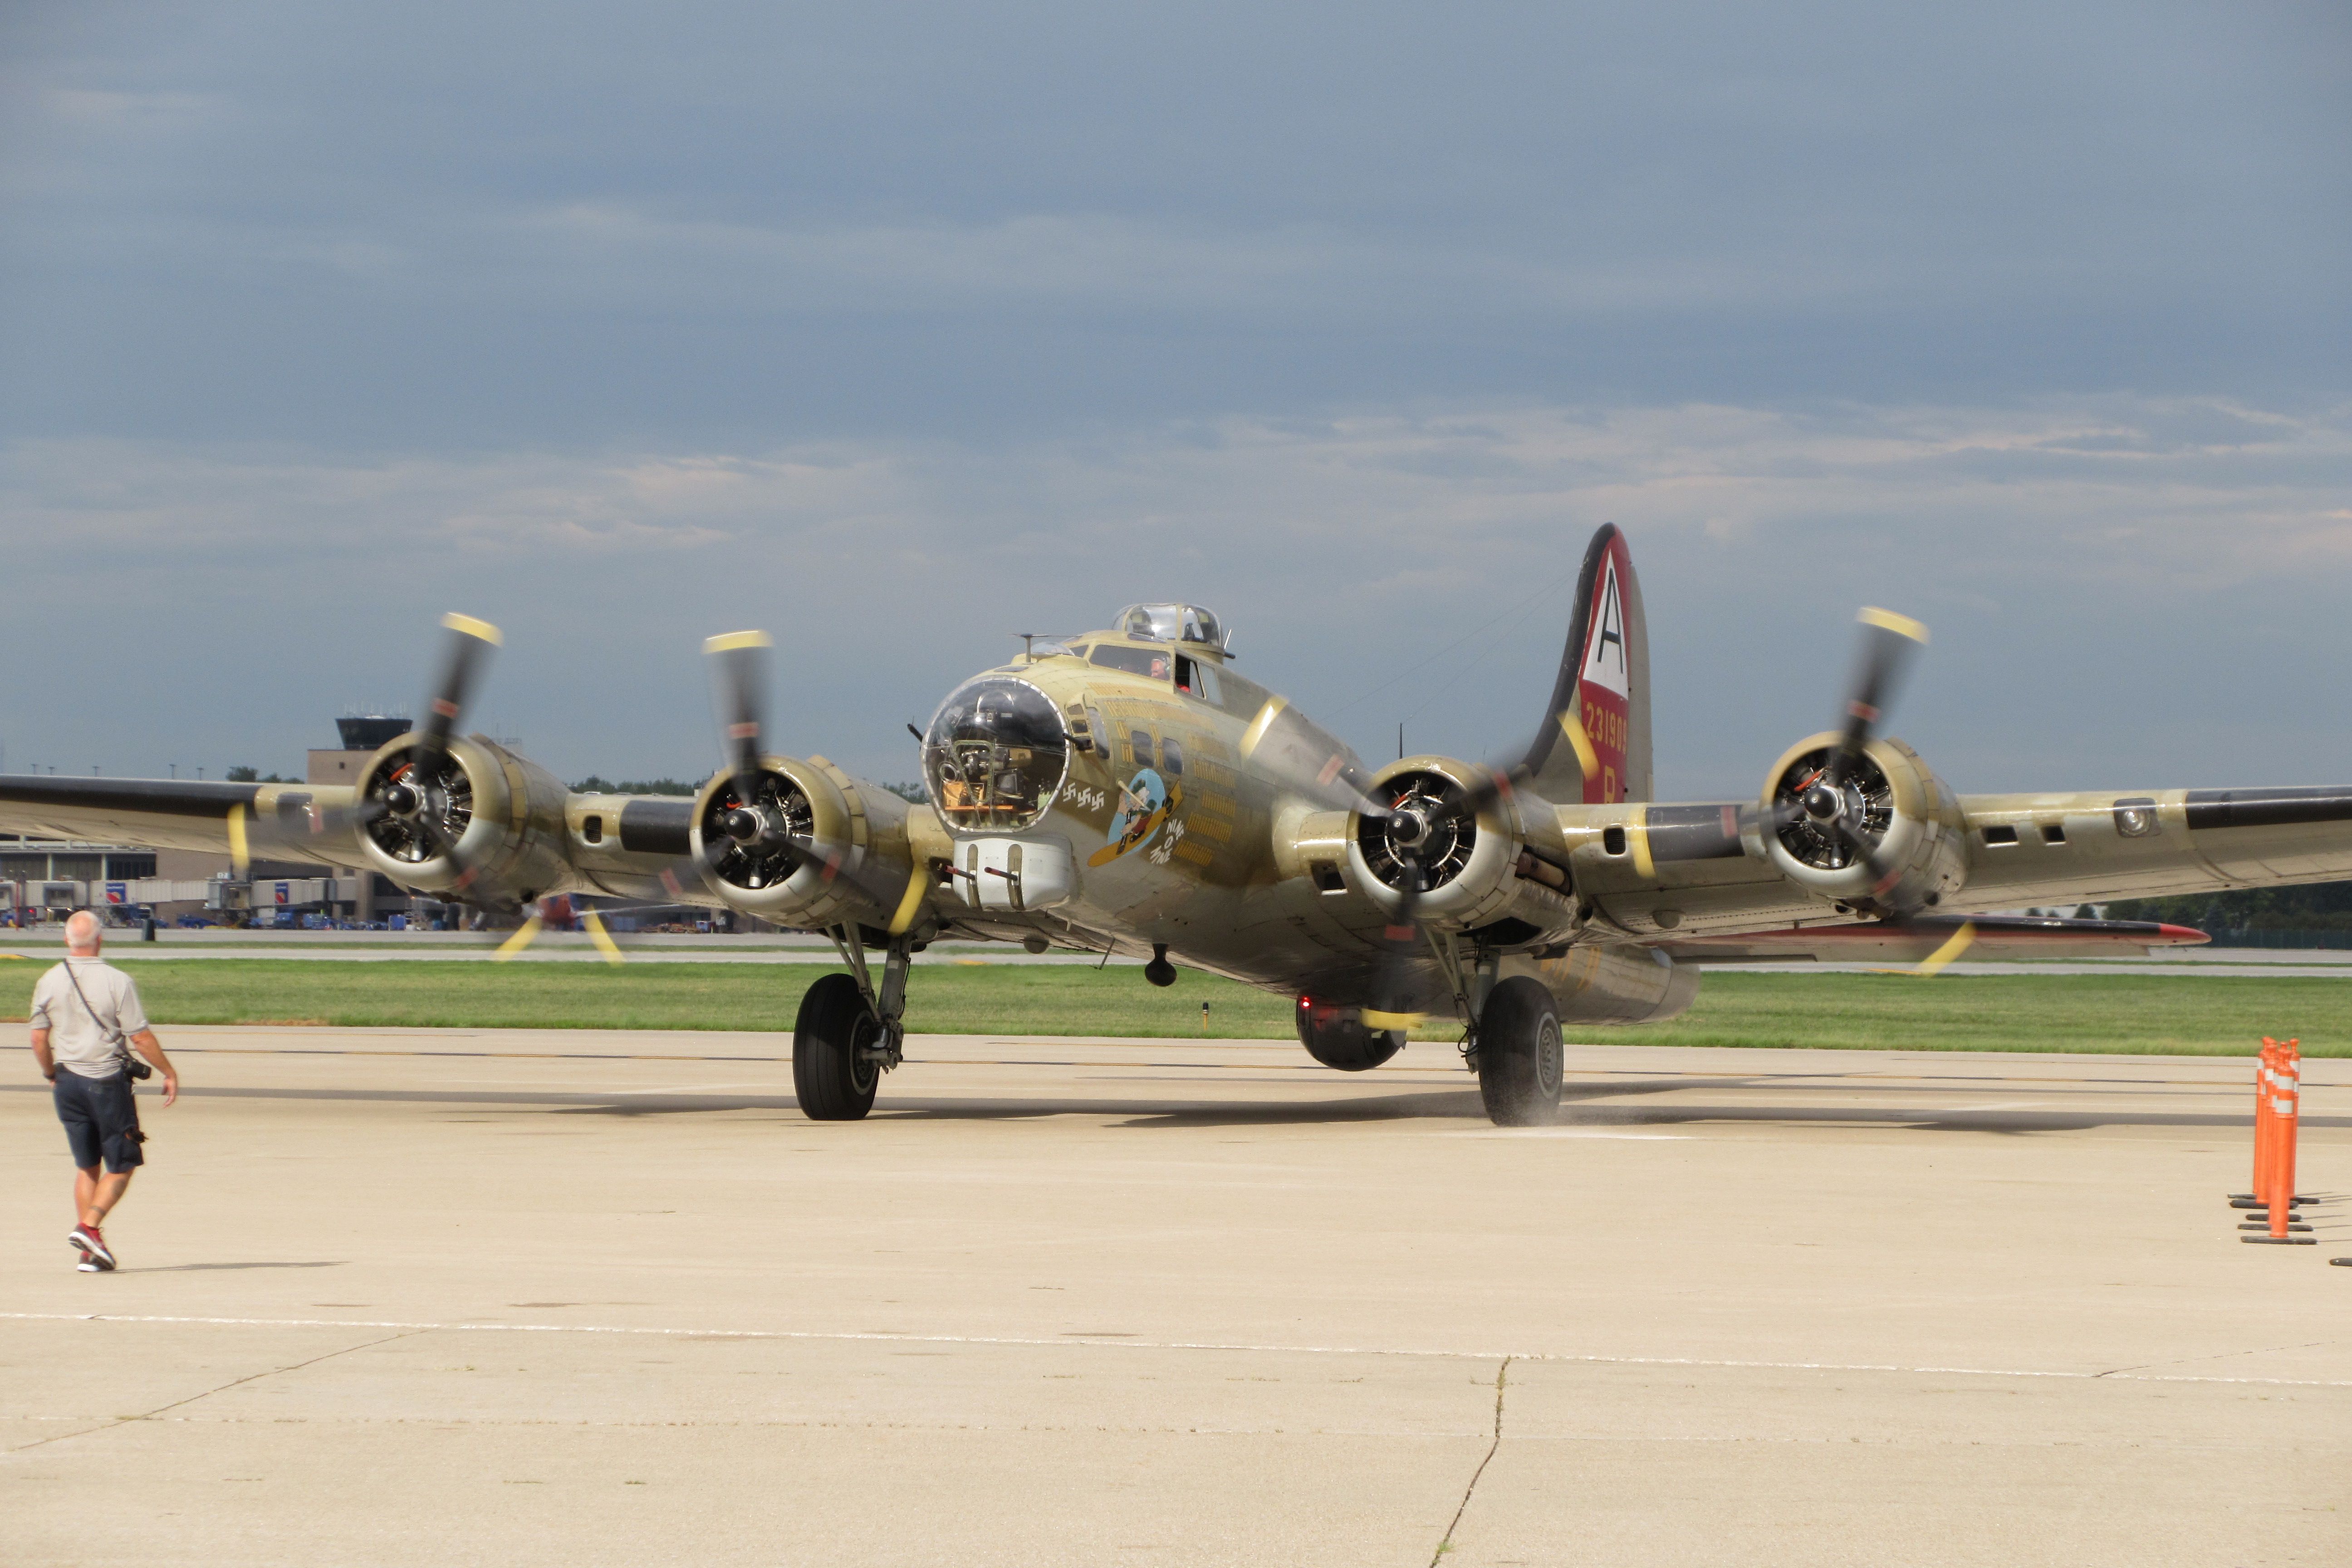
[1656,915,2213,964]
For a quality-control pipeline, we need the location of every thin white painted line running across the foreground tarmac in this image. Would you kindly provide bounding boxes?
[0,1312,2352,1389]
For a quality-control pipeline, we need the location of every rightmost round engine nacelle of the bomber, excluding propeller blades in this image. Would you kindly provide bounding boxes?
[1764,731,1969,907]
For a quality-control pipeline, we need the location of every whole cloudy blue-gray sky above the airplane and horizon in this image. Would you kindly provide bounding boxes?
[0,0,2352,794]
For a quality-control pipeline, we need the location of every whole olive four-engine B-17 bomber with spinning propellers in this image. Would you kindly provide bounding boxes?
[0,527,2352,1124]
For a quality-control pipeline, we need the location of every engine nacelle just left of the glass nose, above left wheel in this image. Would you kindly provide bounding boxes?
[687,757,912,926]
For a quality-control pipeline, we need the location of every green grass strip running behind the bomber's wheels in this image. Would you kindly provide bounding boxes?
[5,959,2352,1055]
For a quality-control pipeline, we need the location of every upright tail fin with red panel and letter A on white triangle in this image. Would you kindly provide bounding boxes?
[1526,522,1651,804]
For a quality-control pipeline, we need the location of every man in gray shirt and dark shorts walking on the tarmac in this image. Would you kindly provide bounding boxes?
[33,910,179,1274]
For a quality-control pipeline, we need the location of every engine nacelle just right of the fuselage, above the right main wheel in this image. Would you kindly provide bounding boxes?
[1345,757,1576,941]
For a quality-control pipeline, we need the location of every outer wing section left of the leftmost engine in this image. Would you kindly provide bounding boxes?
[0,774,362,867]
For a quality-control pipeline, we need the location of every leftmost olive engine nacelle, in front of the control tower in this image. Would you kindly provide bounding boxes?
[358,734,572,905]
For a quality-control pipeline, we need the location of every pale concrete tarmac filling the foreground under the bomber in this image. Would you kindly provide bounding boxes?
[0,1027,2352,1568]
